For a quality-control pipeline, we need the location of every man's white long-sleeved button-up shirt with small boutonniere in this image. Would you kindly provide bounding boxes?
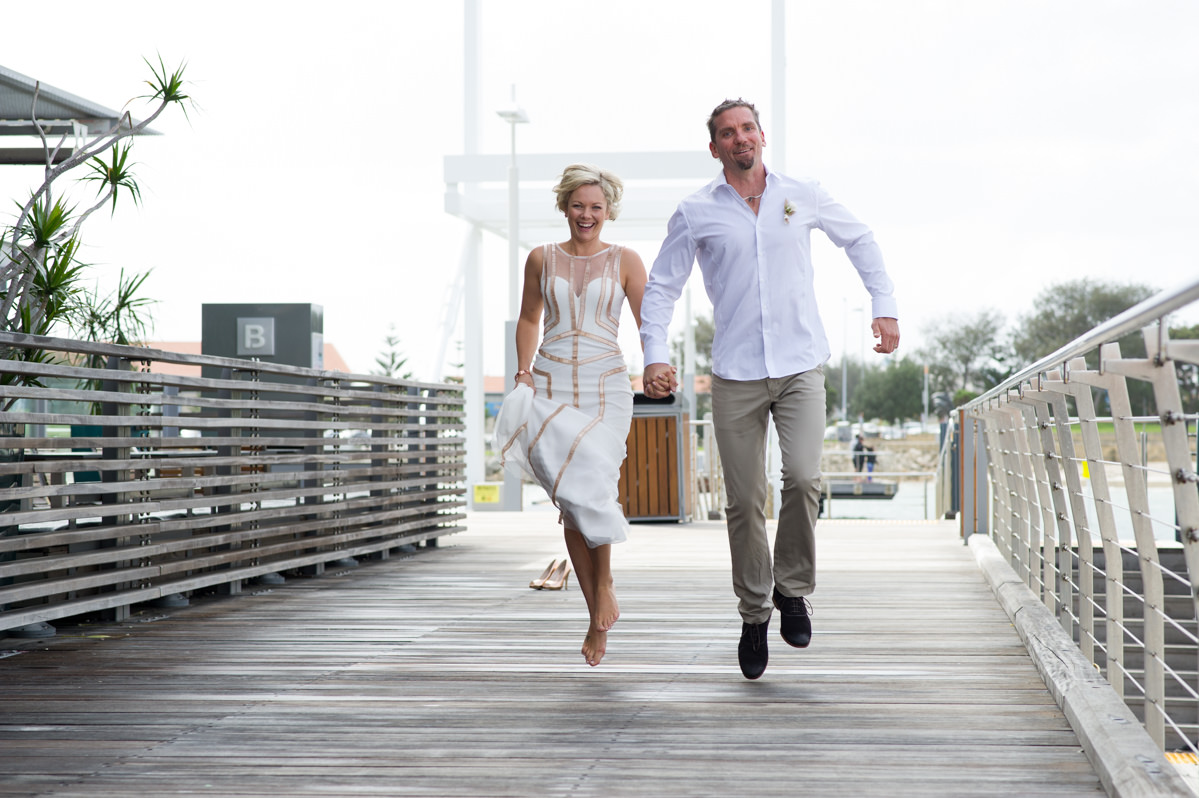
[641,170,899,380]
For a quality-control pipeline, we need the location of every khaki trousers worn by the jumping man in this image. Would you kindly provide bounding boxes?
[712,368,825,623]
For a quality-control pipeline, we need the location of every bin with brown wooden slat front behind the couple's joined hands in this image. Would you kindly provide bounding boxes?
[617,394,691,521]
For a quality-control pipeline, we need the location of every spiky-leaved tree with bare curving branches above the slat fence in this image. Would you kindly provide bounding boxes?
[0,58,191,406]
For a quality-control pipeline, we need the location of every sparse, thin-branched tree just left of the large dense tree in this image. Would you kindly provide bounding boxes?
[917,309,1007,393]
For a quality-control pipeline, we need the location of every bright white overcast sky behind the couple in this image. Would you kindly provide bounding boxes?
[0,0,1199,379]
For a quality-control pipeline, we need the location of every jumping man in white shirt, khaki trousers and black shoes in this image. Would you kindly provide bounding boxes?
[641,99,899,679]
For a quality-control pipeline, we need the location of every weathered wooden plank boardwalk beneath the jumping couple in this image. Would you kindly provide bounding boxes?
[0,510,1103,798]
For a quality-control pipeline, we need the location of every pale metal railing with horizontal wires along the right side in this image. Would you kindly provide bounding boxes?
[942,282,1199,755]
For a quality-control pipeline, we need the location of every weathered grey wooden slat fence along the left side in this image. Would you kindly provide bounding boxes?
[0,333,465,630]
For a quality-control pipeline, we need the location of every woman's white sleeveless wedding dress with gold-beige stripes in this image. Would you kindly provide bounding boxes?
[495,243,633,548]
